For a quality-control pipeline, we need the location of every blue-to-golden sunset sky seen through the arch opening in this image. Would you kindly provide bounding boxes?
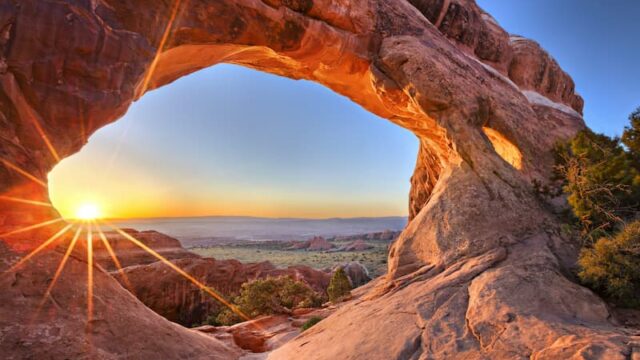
[49,65,418,218]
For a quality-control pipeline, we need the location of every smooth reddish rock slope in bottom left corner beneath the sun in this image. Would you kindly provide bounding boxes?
[0,238,243,360]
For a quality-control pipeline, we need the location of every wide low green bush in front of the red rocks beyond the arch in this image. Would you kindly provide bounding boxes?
[216,276,324,325]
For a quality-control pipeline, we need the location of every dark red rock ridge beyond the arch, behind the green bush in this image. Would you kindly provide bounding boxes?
[117,258,330,326]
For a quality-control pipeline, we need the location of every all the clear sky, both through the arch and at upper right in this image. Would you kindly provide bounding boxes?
[50,0,640,217]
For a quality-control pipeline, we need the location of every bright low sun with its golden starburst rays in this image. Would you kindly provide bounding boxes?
[0,0,250,334]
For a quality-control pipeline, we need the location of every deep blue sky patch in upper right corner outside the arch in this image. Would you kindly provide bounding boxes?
[477,0,640,135]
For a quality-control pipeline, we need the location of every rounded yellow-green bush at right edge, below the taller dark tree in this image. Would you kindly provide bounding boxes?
[578,221,640,308]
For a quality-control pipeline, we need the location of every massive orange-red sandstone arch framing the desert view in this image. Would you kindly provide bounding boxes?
[0,0,638,359]
